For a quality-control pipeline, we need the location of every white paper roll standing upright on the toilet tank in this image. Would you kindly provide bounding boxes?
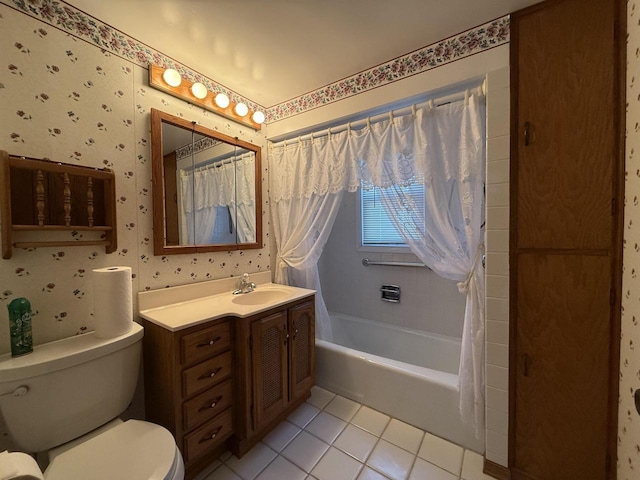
[93,267,133,338]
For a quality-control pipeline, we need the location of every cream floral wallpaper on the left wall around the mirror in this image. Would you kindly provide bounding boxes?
[0,0,270,353]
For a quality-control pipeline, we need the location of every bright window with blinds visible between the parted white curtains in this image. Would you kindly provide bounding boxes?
[360,183,425,248]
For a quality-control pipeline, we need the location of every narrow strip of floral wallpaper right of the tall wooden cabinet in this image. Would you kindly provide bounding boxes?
[618,0,640,480]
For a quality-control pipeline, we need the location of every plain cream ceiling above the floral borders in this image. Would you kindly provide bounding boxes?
[67,0,540,107]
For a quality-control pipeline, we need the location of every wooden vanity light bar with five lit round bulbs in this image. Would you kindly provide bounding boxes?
[149,64,265,130]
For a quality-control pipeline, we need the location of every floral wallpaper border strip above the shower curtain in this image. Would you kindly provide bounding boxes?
[266,15,510,122]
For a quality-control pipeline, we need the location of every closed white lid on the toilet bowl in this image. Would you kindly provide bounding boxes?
[44,420,180,480]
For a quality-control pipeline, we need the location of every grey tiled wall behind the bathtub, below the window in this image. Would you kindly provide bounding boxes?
[318,192,465,338]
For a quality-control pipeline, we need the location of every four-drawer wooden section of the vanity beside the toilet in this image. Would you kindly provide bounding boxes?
[143,319,234,479]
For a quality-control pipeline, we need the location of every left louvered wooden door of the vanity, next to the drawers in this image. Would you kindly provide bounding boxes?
[251,311,289,431]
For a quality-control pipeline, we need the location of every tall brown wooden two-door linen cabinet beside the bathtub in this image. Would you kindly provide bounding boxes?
[509,0,626,480]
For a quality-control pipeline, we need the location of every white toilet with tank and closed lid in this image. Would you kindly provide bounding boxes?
[0,323,184,480]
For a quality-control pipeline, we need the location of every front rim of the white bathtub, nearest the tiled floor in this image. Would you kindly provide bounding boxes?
[316,338,460,392]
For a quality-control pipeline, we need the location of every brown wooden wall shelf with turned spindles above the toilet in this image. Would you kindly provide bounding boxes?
[0,150,117,259]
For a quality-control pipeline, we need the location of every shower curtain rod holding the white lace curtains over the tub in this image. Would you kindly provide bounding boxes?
[269,80,486,148]
